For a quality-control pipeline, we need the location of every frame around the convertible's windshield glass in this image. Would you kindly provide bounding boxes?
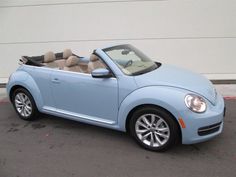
[102,44,161,76]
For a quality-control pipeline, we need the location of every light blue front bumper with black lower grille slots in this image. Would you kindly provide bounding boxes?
[181,92,225,144]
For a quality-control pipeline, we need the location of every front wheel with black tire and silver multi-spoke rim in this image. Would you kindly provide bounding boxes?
[130,106,180,152]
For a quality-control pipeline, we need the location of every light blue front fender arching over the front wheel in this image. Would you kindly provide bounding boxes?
[118,86,186,131]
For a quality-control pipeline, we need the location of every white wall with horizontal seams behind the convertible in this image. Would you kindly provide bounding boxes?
[0,0,236,82]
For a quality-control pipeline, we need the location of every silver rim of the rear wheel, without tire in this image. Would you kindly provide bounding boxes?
[15,93,32,117]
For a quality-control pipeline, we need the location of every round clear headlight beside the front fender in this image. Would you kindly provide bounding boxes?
[185,94,207,113]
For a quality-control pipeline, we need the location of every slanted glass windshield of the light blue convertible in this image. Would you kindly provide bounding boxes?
[103,44,159,76]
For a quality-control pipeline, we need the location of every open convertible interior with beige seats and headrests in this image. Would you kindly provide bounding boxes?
[20,49,106,73]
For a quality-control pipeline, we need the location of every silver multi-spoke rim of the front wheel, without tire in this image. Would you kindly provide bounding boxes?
[135,114,170,147]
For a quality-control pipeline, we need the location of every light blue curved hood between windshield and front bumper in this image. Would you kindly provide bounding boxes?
[134,64,216,104]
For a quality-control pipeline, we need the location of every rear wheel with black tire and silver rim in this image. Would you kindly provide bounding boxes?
[11,88,39,121]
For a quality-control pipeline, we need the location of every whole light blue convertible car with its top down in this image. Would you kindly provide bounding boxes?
[7,44,225,151]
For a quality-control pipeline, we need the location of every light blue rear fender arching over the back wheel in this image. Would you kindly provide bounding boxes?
[7,70,43,110]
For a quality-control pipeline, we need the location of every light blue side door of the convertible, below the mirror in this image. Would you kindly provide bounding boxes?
[51,70,118,124]
